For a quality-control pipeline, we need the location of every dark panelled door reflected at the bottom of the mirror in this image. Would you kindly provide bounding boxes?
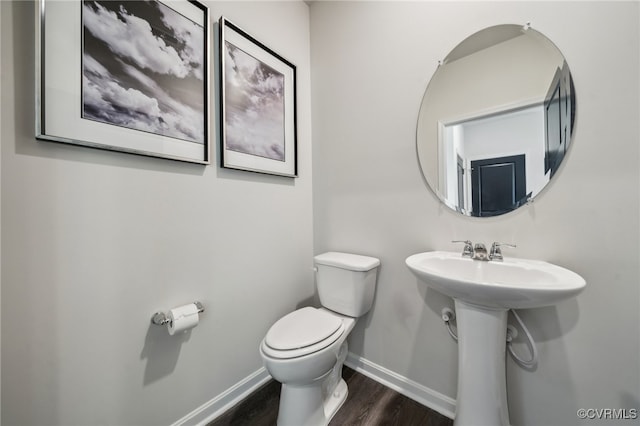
[471,154,527,217]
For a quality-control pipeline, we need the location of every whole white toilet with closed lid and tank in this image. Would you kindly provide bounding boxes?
[260,252,380,426]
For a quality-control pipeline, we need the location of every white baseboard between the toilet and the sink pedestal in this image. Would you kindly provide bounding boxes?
[345,352,456,419]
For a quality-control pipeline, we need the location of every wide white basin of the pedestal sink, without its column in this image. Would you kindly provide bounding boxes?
[406,251,586,309]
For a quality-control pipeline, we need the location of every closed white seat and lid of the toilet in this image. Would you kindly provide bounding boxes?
[262,307,344,359]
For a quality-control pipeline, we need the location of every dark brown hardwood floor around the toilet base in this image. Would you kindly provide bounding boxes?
[207,366,453,426]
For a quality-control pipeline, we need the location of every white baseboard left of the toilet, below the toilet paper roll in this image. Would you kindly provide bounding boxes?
[171,367,271,426]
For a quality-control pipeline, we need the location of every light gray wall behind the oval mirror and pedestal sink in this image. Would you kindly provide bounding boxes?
[310,2,640,425]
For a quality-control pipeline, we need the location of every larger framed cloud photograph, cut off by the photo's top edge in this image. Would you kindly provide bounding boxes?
[36,0,210,164]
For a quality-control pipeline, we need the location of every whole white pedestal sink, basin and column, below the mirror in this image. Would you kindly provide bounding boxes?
[406,251,586,426]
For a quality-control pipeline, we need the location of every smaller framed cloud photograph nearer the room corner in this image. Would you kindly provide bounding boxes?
[219,17,298,177]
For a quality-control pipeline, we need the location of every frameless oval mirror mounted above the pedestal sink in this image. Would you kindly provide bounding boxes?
[417,25,576,217]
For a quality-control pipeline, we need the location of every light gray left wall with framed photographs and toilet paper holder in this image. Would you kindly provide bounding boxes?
[0,1,314,425]
